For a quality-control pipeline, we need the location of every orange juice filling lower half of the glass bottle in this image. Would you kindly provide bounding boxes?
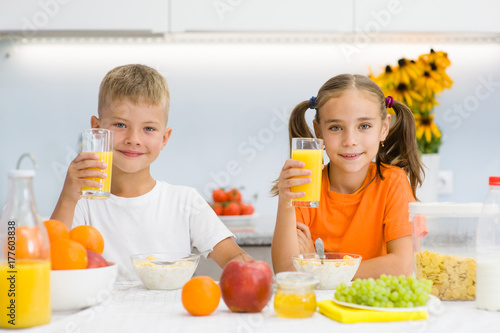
[0,260,52,328]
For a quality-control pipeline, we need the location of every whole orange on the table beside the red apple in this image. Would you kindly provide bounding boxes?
[182,276,221,316]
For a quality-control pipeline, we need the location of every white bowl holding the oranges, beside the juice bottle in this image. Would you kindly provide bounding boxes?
[50,263,118,311]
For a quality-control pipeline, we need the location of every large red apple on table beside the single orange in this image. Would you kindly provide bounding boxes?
[219,260,273,312]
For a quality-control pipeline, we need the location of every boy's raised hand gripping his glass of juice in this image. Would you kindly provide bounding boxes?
[60,152,106,202]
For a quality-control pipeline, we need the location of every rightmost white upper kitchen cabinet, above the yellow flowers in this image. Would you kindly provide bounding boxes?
[354,0,500,33]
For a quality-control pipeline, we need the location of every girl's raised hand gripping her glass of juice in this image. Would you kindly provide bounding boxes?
[278,159,312,202]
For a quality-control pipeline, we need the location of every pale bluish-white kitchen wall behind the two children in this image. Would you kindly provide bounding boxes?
[0,42,500,220]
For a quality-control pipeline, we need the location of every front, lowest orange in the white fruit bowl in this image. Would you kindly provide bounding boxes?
[50,238,88,270]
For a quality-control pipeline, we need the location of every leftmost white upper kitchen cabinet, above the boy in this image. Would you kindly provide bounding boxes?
[0,0,169,36]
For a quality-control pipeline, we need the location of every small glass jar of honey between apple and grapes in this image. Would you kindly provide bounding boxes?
[274,272,319,318]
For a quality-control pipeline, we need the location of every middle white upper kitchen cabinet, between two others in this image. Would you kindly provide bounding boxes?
[170,0,353,33]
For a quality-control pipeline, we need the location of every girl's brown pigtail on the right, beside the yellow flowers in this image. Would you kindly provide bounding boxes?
[376,100,424,198]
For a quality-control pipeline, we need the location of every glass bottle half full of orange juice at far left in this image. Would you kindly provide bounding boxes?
[0,156,51,328]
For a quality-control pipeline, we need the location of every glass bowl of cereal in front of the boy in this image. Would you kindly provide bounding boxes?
[130,253,201,290]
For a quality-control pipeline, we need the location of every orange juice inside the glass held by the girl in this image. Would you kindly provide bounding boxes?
[291,149,323,207]
